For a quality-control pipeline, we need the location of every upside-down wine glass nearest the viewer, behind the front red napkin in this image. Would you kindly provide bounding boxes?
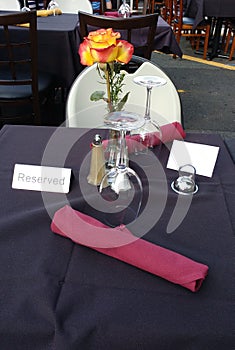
[99,111,144,226]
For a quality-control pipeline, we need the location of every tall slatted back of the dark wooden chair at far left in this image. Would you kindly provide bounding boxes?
[0,11,40,124]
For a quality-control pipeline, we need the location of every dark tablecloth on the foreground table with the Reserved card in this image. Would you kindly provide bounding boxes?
[0,126,235,350]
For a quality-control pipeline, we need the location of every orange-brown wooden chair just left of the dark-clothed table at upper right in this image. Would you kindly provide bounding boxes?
[173,0,210,59]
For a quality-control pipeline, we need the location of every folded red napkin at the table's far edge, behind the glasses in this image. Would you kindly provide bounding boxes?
[103,122,186,154]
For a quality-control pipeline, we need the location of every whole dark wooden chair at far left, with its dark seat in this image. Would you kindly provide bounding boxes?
[0,11,53,125]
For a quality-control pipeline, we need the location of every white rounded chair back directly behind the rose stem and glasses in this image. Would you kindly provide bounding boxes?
[66,56,182,128]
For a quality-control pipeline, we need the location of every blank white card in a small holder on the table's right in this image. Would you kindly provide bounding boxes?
[167,140,219,177]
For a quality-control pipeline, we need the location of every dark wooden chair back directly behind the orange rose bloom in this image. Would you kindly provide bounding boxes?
[79,12,158,59]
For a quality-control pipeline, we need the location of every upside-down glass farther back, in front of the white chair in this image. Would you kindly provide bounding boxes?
[133,75,166,153]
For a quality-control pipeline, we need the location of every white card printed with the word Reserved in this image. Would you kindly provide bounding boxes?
[12,164,71,193]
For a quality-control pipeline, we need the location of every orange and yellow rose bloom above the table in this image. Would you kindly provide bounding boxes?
[78,28,134,66]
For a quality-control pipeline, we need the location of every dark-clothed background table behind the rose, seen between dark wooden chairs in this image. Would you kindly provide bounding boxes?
[0,11,182,89]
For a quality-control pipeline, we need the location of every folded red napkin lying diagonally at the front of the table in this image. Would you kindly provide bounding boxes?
[51,206,208,292]
